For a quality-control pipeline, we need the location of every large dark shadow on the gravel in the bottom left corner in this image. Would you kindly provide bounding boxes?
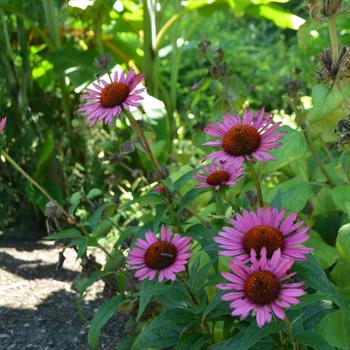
[0,290,124,350]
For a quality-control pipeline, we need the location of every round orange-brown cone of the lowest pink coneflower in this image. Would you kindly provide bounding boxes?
[244,271,281,305]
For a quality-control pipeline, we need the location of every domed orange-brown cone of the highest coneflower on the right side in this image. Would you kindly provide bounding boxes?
[223,125,260,156]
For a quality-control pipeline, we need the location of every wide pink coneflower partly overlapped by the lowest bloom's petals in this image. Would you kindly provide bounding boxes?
[214,208,313,262]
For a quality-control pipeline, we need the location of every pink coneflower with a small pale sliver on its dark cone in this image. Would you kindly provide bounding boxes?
[127,225,191,282]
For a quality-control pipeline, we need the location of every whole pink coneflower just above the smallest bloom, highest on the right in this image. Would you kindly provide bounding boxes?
[204,108,285,165]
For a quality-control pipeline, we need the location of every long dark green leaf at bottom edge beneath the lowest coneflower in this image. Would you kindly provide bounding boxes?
[208,322,279,350]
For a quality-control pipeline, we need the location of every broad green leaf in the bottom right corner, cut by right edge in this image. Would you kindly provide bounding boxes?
[317,310,350,349]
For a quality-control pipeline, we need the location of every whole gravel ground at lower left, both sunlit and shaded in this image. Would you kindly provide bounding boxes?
[0,241,124,350]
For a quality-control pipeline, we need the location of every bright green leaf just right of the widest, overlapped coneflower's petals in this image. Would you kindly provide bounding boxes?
[306,231,339,269]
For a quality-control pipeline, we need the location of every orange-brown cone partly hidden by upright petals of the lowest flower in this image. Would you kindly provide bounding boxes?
[243,225,284,258]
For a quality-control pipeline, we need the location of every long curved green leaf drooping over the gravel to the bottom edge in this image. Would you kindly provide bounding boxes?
[88,295,124,350]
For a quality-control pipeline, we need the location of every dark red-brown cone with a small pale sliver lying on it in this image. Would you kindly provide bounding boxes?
[145,241,177,271]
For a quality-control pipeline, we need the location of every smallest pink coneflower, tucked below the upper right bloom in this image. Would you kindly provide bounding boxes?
[194,163,243,191]
